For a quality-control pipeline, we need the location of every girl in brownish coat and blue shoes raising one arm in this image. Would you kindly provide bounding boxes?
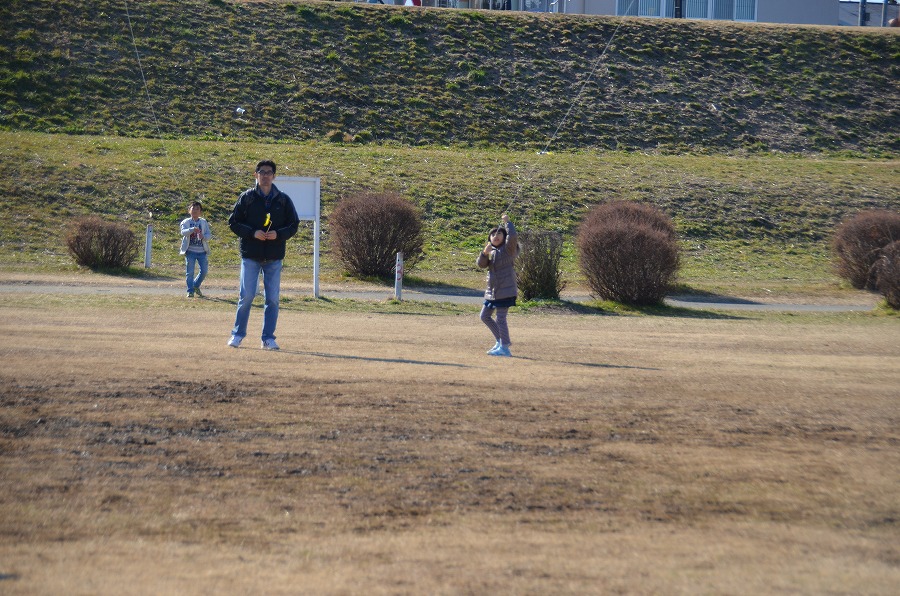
[476,213,519,356]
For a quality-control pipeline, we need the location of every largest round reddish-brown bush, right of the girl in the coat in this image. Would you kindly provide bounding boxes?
[577,202,679,305]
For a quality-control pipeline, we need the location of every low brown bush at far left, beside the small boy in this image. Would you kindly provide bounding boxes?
[66,215,139,269]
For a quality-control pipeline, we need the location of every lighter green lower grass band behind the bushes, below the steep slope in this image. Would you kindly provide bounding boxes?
[0,132,898,294]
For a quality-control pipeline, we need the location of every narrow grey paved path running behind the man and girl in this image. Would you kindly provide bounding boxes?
[0,280,874,312]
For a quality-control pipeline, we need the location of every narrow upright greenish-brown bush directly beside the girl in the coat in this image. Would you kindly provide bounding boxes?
[516,231,566,300]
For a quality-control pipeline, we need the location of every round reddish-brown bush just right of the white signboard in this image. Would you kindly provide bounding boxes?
[329,191,424,277]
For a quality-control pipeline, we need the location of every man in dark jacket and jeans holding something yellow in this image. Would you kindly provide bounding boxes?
[228,160,300,350]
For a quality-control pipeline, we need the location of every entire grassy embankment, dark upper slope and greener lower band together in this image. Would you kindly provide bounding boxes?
[0,0,900,294]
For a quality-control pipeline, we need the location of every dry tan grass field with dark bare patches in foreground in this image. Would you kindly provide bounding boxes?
[0,295,900,594]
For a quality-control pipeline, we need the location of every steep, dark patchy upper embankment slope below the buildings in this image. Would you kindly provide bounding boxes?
[0,0,900,154]
